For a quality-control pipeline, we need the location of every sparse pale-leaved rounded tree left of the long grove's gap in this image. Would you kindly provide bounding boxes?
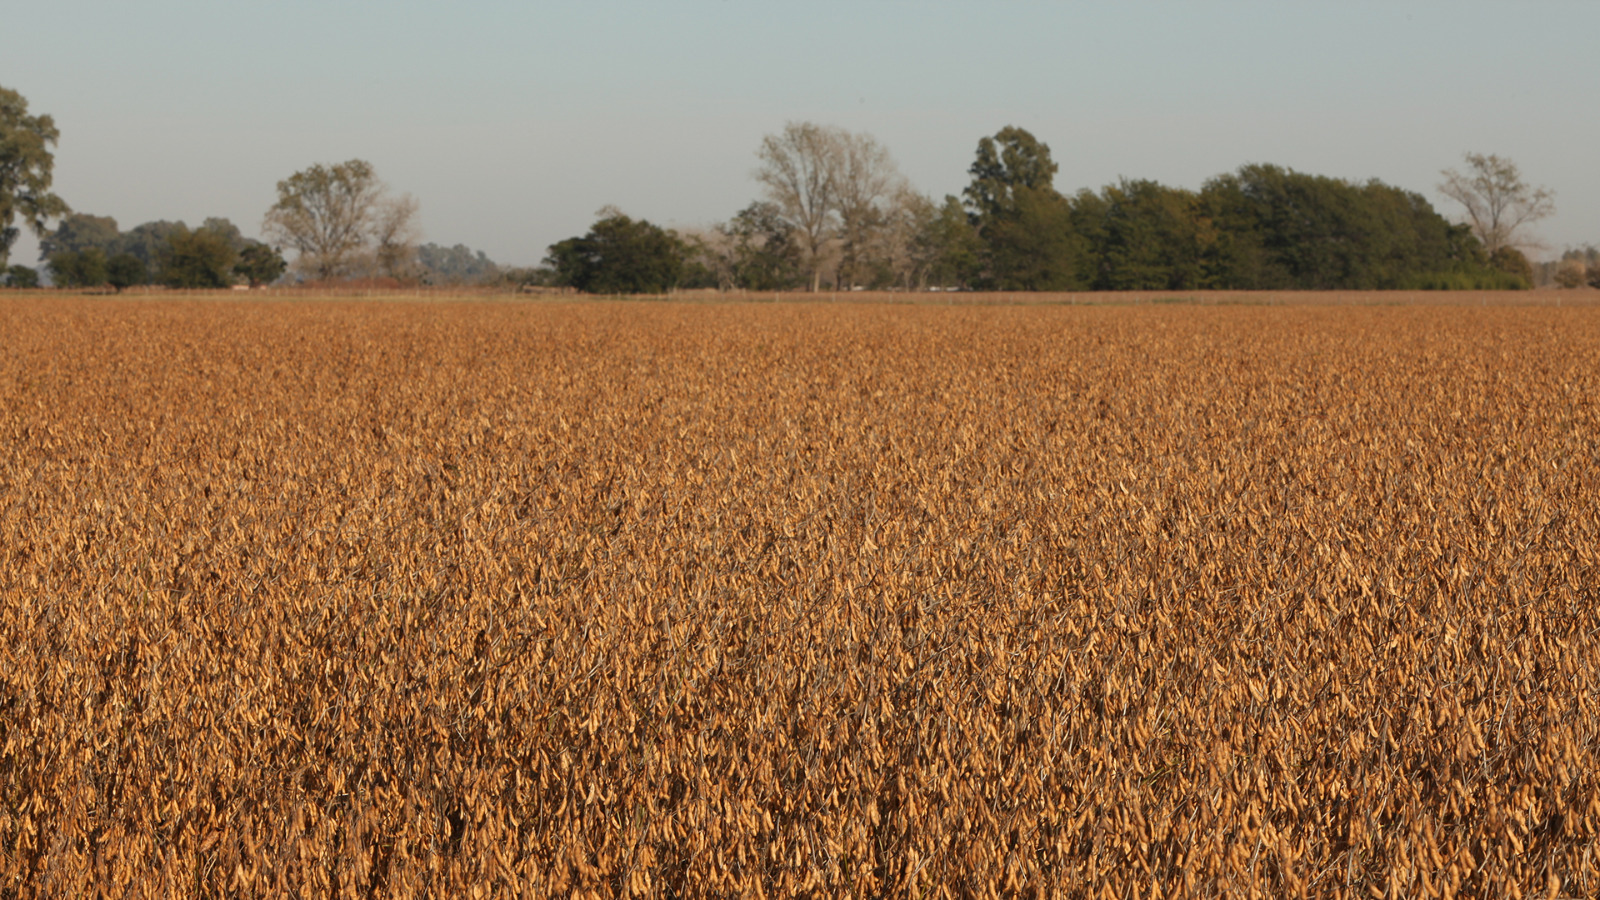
[261,160,418,280]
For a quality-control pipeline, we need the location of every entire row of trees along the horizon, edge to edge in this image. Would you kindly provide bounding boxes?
[0,81,1568,293]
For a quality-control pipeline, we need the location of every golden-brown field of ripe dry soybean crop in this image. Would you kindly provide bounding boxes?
[0,295,1600,898]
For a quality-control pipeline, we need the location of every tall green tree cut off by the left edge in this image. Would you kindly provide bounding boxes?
[0,88,70,266]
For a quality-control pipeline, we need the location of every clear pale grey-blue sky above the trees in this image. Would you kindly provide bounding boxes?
[9,0,1600,264]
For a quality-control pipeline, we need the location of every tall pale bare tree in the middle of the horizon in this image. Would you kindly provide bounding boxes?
[755,122,846,293]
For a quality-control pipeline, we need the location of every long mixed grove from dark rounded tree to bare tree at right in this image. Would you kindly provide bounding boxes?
[542,122,1554,293]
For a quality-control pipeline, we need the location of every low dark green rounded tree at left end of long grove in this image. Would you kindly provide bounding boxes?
[546,207,688,293]
